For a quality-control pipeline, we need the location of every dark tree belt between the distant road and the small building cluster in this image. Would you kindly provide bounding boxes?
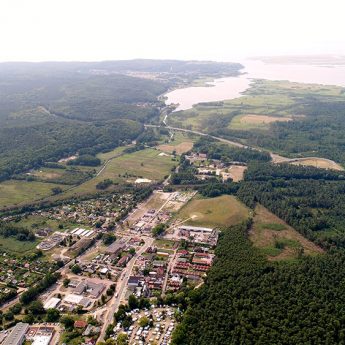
[194,137,271,163]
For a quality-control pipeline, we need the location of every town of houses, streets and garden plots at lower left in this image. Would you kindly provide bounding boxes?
[0,185,219,345]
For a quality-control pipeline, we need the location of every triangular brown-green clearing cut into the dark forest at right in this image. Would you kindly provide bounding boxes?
[249,205,323,261]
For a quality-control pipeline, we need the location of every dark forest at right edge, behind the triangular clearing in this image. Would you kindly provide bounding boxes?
[237,163,345,249]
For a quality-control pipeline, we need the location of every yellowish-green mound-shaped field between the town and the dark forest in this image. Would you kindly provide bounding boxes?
[176,195,249,227]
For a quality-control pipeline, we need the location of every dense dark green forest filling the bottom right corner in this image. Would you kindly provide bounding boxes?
[172,224,345,345]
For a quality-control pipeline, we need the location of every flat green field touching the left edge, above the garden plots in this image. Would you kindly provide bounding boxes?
[0,180,67,208]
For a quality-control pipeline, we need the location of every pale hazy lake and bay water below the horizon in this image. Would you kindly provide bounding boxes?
[166,60,345,111]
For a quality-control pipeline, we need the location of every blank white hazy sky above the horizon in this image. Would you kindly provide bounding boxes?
[0,0,345,61]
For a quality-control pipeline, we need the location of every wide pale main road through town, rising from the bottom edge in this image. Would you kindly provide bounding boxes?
[98,237,154,341]
